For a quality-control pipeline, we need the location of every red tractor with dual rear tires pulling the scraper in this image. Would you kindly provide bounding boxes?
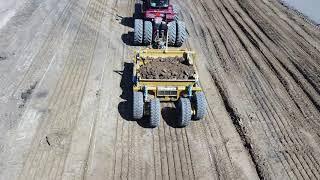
[133,0,187,48]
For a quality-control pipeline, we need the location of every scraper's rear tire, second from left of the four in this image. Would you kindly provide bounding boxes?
[149,98,161,128]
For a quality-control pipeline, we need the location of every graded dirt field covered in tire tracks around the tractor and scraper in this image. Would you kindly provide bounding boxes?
[0,0,320,180]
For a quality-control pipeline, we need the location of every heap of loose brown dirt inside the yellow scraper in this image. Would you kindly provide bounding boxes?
[140,57,195,80]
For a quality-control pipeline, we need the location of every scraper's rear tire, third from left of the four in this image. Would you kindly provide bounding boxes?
[177,98,192,127]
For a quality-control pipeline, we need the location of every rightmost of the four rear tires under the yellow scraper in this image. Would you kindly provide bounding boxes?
[192,92,207,120]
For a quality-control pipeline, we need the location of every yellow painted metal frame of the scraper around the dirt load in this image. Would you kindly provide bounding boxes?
[133,49,202,101]
